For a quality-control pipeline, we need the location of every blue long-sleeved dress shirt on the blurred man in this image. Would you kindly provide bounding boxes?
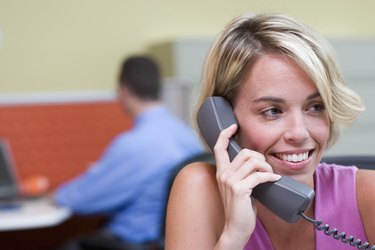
[54,106,203,243]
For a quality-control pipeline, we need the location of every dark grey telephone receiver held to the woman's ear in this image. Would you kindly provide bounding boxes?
[197,96,315,223]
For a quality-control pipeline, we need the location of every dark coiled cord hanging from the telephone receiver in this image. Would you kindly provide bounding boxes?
[300,212,375,250]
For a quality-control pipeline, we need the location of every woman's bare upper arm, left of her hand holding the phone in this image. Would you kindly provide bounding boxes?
[166,162,224,250]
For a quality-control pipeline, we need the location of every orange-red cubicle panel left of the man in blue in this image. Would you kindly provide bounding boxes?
[0,101,132,189]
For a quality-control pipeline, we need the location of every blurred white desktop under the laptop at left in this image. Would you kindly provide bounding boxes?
[0,198,71,231]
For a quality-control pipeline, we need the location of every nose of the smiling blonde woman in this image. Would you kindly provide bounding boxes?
[284,112,310,144]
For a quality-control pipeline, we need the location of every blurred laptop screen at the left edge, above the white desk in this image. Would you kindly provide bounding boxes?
[0,139,18,199]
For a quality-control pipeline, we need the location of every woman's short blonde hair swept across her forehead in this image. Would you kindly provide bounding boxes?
[193,14,364,146]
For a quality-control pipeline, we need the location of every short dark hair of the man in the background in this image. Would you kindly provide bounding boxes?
[119,56,160,100]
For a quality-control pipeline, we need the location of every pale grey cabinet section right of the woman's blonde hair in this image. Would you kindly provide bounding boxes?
[327,40,375,155]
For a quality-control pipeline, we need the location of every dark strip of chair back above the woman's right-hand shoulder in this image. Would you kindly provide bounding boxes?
[322,155,375,170]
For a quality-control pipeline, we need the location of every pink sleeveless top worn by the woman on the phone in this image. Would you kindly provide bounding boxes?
[244,163,367,250]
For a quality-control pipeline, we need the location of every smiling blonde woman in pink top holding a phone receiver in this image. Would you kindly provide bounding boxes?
[166,14,375,250]
